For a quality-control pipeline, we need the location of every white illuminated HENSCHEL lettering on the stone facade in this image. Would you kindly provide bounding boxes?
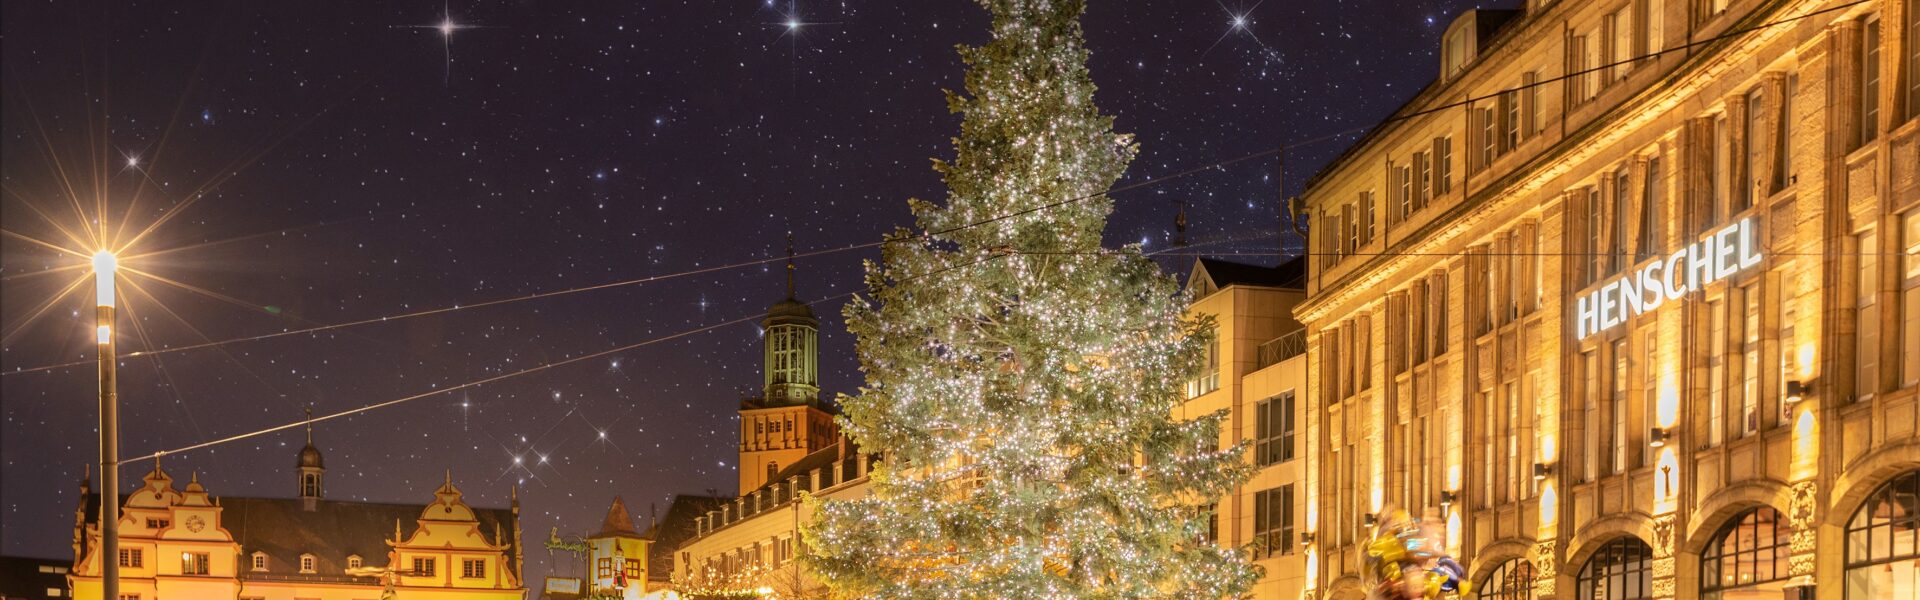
[1574,217,1761,338]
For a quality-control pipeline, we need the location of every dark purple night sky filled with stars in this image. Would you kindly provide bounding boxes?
[0,0,1473,588]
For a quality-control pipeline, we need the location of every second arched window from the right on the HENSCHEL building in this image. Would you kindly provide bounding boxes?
[1699,506,1793,600]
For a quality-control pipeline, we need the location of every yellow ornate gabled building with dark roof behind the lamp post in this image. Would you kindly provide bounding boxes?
[67,431,526,600]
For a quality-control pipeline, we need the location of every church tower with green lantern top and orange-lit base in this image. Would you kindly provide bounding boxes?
[739,235,835,494]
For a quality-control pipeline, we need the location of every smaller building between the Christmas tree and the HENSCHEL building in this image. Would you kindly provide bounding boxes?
[1175,258,1311,598]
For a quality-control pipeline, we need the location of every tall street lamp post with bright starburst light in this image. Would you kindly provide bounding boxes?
[94,250,119,600]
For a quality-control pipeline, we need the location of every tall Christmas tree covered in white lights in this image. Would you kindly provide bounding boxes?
[806,0,1256,598]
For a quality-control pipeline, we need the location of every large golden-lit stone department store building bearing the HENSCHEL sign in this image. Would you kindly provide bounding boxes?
[1296,0,1920,600]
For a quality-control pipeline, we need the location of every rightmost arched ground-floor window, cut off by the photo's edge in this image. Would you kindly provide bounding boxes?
[1847,471,1920,600]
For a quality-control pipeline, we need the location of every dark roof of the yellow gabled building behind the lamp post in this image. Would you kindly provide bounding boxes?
[86,492,522,585]
